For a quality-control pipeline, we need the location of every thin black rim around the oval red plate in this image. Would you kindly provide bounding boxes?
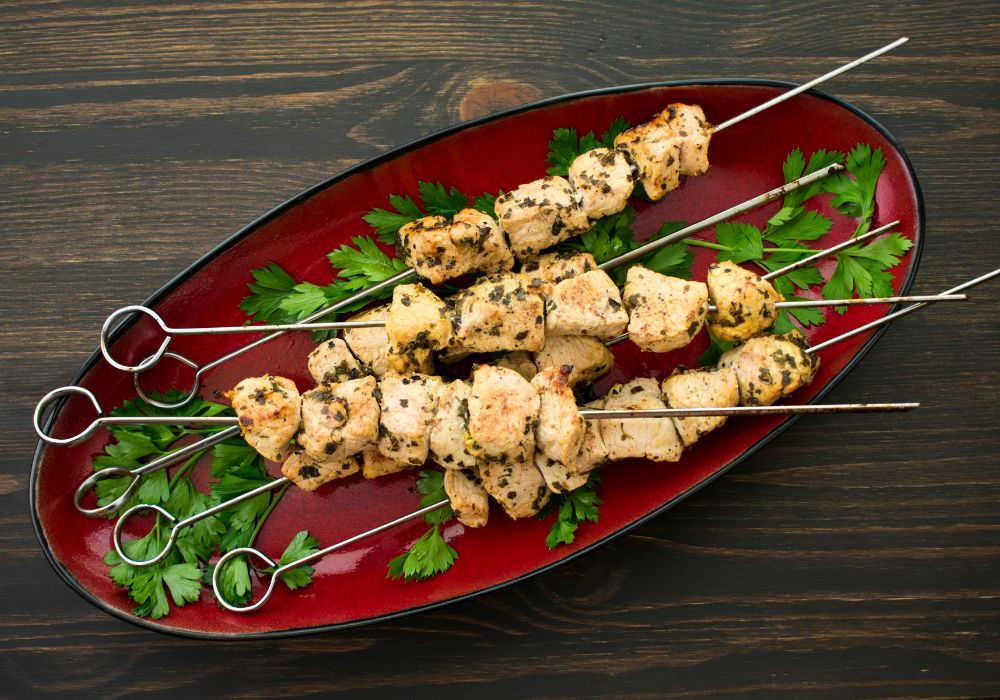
[28,78,926,640]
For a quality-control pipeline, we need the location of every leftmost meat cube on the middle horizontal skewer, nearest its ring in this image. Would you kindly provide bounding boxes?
[385,284,452,372]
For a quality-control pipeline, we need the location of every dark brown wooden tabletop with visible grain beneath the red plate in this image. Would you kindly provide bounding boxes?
[0,1,1000,697]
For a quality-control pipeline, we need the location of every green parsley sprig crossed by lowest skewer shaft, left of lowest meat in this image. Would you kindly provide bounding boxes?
[388,469,458,581]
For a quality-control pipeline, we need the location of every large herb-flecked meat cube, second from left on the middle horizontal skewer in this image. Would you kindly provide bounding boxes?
[452,275,545,353]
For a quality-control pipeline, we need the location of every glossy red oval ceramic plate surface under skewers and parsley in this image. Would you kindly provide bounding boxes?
[31,82,923,637]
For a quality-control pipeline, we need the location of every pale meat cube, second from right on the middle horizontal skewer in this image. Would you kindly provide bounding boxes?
[622,265,708,352]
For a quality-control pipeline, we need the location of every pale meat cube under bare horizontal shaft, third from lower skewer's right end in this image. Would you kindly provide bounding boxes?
[601,377,684,462]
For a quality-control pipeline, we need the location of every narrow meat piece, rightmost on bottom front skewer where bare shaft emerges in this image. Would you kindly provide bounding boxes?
[531,365,586,464]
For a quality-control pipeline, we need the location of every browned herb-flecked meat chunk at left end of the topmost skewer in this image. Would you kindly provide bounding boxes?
[398,209,514,284]
